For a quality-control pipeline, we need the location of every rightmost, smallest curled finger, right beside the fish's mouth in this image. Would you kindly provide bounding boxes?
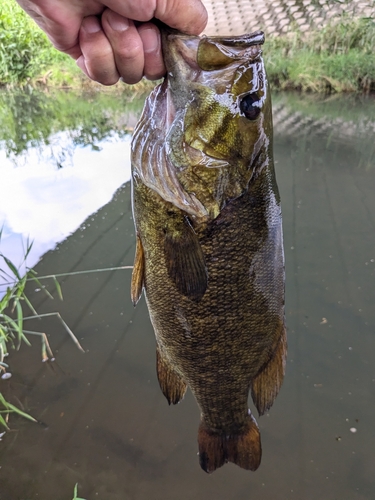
[138,23,166,80]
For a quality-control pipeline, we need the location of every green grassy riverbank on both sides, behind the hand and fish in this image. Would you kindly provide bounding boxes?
[0,0,375,93]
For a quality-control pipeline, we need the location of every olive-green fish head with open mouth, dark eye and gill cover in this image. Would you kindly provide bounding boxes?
[133,30,272,219]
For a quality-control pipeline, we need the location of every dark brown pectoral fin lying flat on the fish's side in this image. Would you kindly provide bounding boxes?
[164,218,207,302]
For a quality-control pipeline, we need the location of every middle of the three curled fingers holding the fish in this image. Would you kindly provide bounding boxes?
[102,9,144,84]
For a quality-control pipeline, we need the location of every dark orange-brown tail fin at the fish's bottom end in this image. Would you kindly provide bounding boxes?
[198,410,262,473]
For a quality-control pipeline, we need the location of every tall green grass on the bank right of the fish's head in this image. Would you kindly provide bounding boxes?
[264,15,375,93]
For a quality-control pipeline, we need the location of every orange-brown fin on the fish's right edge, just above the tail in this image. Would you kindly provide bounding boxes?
[251,321,287,415]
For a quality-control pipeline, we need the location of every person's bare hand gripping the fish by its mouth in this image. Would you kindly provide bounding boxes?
[17,0,207,85]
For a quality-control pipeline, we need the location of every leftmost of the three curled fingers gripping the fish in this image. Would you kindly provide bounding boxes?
[77,16,120,85]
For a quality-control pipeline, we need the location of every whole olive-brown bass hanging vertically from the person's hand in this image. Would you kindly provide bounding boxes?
[131,29,287,473]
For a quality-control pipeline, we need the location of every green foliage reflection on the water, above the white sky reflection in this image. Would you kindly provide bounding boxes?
[0,86,144,160]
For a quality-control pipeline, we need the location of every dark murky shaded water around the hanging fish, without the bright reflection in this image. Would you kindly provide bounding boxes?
[0,91,375,500]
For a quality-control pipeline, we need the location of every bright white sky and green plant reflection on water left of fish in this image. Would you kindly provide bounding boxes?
[0,89,145,292]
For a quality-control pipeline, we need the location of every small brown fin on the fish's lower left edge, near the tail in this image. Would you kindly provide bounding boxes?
[156,346,187,405]
